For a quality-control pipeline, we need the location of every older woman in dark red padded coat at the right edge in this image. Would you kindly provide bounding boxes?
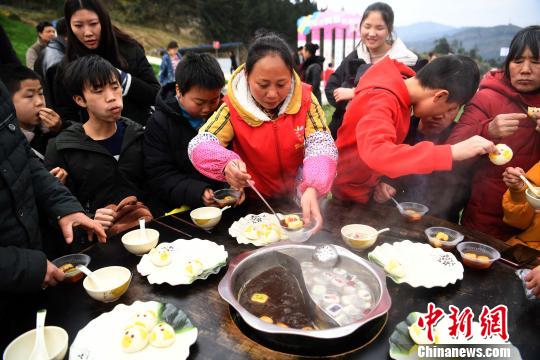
[448,26,540,240]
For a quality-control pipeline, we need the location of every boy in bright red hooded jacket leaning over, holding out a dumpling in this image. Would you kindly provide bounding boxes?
[332,55,496,203]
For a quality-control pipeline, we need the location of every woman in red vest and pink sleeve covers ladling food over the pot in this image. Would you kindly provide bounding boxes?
[188,34,337,228]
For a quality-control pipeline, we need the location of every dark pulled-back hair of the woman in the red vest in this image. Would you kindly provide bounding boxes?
[246,33,294,74]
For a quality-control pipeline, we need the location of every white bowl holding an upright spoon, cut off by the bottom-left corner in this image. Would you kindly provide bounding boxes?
[4,326,68,360]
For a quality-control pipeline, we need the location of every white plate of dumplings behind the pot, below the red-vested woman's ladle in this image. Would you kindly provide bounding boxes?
[229,213,288,246]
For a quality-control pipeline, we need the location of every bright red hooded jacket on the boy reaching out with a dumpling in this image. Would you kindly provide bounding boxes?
[332,57,452,203]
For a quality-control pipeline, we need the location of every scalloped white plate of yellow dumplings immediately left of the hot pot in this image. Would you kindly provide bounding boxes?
[137,239,228,286]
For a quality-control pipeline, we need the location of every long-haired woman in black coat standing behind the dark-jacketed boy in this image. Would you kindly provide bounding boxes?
[54,0,160,125]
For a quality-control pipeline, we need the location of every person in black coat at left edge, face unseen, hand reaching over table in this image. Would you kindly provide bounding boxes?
[0,81,106,348]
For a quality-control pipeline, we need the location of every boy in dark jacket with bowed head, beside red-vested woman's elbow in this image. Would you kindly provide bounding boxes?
[144,54,225,214]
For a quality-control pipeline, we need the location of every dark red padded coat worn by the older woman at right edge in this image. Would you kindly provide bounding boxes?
[447,70,540,240]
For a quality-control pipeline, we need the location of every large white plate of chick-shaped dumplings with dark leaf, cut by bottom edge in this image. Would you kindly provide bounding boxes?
[69,301,198,360]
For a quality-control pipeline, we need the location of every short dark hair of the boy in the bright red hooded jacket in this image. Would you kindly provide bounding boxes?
[416,55,480,105]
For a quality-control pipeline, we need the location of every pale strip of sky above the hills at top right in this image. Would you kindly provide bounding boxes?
[316,0,540,27]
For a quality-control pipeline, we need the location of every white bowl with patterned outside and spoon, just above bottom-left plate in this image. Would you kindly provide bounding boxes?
[83,266,131,302]
